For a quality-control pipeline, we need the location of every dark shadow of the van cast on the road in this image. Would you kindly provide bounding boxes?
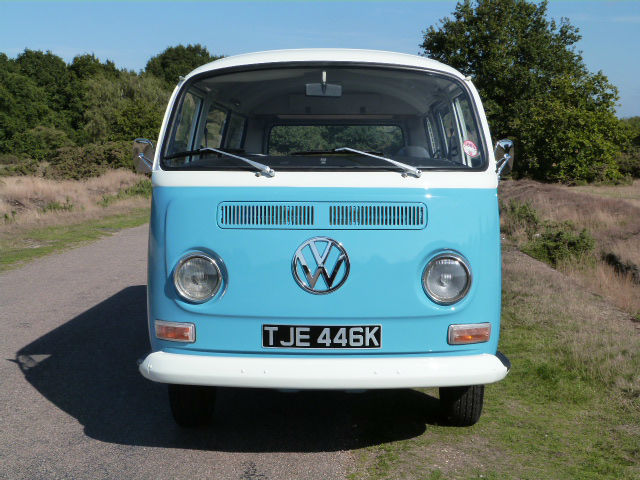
[16,285,438,452]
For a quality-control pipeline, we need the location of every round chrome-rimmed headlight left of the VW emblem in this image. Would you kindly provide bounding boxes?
[173,253,222,303]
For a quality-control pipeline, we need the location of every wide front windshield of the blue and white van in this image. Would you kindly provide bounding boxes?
[161,66,486,172]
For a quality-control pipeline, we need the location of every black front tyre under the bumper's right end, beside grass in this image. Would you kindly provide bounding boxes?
[440,385,484,427]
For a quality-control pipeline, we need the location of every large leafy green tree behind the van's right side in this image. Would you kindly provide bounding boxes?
[421,0,626,183]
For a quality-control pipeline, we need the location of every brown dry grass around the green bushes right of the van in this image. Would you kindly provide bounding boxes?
[500,180,640,315]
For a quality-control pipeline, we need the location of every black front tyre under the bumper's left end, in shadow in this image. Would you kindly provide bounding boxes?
[169,384,216,428]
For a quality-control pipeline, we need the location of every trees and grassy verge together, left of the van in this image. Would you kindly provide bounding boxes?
[0,45,219,270]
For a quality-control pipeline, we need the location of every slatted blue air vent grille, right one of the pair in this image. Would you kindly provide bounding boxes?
[329,203,426,229]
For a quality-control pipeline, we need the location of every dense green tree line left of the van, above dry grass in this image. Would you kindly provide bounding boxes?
[0,45,219,178]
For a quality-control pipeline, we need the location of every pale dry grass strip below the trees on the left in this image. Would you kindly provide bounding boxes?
[0,170,149,235]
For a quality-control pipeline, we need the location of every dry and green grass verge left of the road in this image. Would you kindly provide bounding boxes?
[0,170,151,271]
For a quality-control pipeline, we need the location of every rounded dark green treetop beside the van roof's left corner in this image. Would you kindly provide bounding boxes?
[145,44,222,85]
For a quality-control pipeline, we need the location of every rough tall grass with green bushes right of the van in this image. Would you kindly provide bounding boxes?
[500,181,640,315]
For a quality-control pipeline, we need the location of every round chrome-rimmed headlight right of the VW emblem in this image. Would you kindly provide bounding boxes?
[422,252,471,305]
